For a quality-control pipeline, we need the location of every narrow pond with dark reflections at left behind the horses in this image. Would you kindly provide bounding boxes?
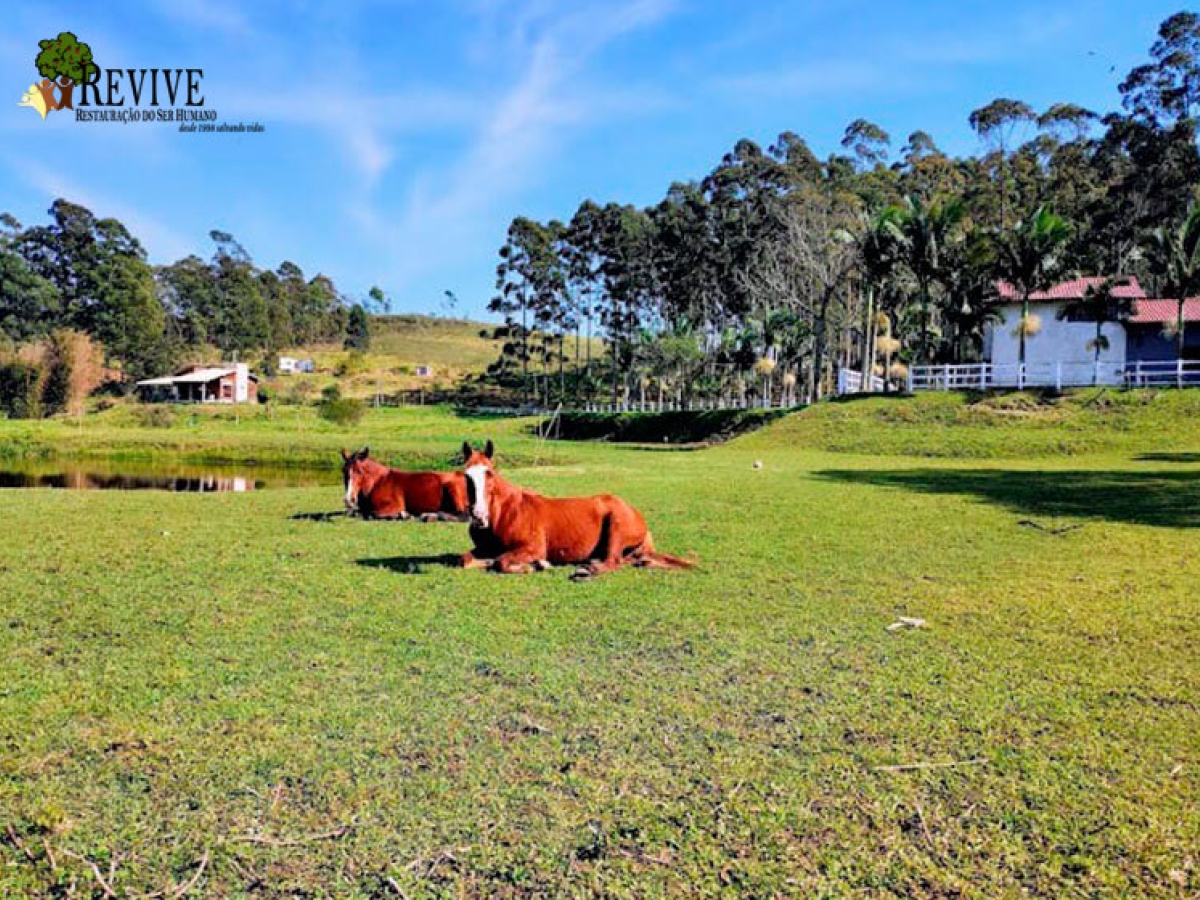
[0,460,341,493]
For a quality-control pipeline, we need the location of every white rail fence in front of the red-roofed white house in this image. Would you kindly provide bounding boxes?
[902,360,1200,391]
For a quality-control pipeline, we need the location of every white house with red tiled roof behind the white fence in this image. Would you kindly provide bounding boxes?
[984,277,1200,386]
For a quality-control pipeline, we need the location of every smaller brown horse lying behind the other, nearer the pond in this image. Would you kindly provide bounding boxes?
[342,448,467,522]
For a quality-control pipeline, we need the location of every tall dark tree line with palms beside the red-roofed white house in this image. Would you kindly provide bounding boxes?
[490,12,1200,403]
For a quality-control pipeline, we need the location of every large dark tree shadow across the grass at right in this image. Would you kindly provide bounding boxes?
[815,469,1200,528]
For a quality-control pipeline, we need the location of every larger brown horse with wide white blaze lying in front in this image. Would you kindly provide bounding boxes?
[462,440,692,578]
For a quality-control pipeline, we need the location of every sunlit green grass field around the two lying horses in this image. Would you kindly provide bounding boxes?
[0,392,1200,900]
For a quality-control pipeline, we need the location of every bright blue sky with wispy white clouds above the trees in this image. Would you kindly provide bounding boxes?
[0,0,1181,314]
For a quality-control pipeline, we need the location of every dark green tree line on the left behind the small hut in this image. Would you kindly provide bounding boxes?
[0,199,372,385]
